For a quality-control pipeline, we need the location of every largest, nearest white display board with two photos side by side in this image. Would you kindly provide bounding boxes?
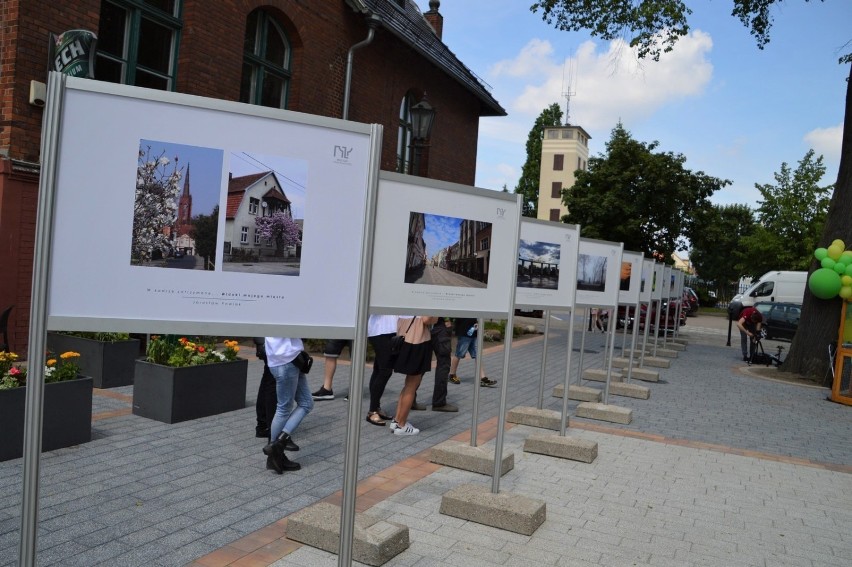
[47,78,381,338]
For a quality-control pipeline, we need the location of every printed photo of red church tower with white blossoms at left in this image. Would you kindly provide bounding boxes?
[130,140,224,270]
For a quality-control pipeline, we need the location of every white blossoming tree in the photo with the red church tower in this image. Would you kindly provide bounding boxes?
[130,146,181,263]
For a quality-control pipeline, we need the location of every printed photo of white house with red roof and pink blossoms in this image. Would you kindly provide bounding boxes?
[222,152,308,276]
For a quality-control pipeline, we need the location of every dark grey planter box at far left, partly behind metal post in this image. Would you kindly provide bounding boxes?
[0,376,92,461]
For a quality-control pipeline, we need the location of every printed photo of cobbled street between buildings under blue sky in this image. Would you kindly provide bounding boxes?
[405,212,491,288]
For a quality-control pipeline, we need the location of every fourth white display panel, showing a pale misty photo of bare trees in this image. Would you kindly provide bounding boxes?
[576,238,624,307]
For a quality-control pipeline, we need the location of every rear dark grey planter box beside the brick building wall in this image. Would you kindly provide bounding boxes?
[47,333,139,388]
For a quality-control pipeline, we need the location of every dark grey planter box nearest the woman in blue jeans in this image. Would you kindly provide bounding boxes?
[133,360,248,423]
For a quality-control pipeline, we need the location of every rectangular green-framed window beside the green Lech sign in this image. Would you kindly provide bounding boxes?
[95,0,183,91]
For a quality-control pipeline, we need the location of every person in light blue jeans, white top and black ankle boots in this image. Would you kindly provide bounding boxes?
[263,337,314,474]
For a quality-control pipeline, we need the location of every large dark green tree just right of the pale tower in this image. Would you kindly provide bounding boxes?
[562,123,729,258]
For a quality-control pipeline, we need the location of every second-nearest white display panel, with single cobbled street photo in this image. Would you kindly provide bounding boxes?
[370,172,521,317]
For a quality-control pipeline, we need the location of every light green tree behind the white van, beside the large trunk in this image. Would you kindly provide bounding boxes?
[743,150,832,276]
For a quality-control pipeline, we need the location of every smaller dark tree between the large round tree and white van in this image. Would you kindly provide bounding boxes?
[688,205,755,300]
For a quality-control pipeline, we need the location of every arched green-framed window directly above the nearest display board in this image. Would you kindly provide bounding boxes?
[240,9,291,108]
